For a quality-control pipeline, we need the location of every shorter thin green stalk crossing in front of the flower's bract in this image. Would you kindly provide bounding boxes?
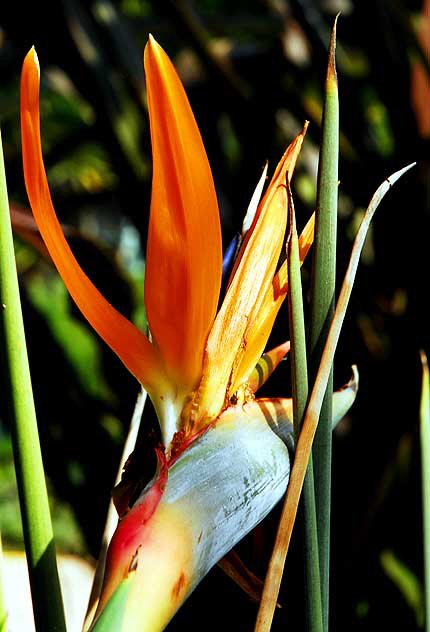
[288,193,323,632]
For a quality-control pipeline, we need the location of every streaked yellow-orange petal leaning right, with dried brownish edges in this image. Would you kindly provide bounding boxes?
[200,125,307,417]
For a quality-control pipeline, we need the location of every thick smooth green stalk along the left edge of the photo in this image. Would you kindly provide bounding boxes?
[0,131,66,632]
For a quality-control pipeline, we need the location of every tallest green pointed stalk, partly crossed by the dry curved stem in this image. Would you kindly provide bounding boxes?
[310,17,339,630]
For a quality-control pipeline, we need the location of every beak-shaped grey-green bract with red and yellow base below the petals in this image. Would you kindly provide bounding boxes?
[92,401,290,632]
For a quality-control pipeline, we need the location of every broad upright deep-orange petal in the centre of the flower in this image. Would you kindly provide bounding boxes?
[145,37,222,391]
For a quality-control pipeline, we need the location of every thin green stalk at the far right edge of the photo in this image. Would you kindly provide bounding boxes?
[420,352,430,632]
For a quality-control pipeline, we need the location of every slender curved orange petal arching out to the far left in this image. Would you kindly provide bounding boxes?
[21,49,165,392]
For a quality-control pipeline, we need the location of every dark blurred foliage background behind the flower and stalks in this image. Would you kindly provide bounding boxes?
[0,0,430,632]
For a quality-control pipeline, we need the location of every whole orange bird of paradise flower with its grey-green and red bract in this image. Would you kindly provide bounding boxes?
[21,37,352,632]
